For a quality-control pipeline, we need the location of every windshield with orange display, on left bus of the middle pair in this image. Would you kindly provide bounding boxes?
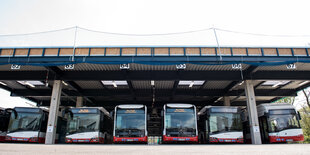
[115,109,146,137]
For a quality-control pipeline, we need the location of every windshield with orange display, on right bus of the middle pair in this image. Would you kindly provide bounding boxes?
[165,108,196,137]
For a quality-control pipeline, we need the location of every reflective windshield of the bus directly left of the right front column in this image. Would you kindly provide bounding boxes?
[209,113,242,133]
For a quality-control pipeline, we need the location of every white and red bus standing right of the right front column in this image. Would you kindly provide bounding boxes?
[257,103,304,143]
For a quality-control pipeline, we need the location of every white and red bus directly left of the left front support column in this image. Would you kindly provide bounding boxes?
[5,107,48,143]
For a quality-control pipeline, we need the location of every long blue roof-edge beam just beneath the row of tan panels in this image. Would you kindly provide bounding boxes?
[0,55,310,66]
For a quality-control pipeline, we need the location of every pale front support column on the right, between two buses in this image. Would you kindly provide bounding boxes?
[244,80,262,144]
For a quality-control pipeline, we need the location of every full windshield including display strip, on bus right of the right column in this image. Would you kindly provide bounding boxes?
[268,110,300,132]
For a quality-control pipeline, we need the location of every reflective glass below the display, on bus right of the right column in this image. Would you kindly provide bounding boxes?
[268,114,300,132]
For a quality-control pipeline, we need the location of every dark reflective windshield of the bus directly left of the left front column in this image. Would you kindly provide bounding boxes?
[8,113,42,132]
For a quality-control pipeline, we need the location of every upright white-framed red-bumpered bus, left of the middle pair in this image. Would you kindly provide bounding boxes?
[113,105,148,144]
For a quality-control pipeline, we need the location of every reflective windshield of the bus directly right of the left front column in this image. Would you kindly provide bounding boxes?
[67,113,100,134]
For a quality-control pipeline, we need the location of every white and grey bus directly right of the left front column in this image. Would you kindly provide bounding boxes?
[66,107,113,143]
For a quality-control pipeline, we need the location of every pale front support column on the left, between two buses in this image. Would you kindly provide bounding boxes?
[45,80,62,144]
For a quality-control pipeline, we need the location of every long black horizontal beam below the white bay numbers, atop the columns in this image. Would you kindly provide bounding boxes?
[0,71,310,80]
